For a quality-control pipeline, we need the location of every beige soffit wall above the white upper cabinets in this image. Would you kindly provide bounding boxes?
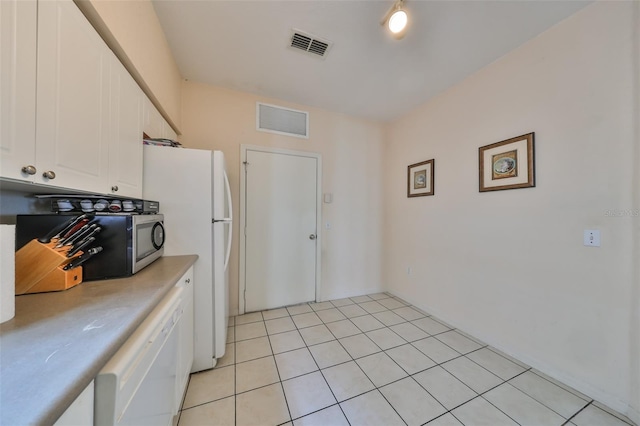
[75,0,182,133]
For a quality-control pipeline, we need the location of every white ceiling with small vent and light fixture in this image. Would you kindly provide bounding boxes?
[153,0,588,121]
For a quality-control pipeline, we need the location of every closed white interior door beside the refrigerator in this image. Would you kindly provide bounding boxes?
[244,150,319,312]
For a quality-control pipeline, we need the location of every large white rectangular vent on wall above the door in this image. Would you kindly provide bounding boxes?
[256,102,309,139]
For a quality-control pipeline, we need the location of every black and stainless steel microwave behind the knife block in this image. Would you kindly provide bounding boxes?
[16,214,165,281]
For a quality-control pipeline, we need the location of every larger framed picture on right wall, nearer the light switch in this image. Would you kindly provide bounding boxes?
[479,132,536,192]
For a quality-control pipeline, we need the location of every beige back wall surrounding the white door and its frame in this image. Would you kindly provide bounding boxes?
[181,82,383,312]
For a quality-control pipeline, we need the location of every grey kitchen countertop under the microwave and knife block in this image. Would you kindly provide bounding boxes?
[0,255,198,425]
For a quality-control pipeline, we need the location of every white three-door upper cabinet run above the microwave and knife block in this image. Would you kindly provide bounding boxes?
[0,0,145,198]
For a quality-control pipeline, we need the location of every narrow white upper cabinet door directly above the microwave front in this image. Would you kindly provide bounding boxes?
[109,56,144,198]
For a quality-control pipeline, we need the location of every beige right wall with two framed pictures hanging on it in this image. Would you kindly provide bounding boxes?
[383,2,640,421]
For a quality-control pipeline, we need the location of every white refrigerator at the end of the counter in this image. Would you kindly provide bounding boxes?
[142,145,233,372]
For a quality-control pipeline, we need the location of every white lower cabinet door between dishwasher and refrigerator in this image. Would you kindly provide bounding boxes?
[176,266,194,409]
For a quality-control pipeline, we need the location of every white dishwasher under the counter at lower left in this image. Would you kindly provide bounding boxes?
[94,287,184,426]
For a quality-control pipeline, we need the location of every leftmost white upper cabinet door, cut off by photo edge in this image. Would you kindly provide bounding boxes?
[0,0,37,181]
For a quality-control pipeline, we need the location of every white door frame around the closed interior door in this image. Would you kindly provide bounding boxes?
[238,144,322,315]
